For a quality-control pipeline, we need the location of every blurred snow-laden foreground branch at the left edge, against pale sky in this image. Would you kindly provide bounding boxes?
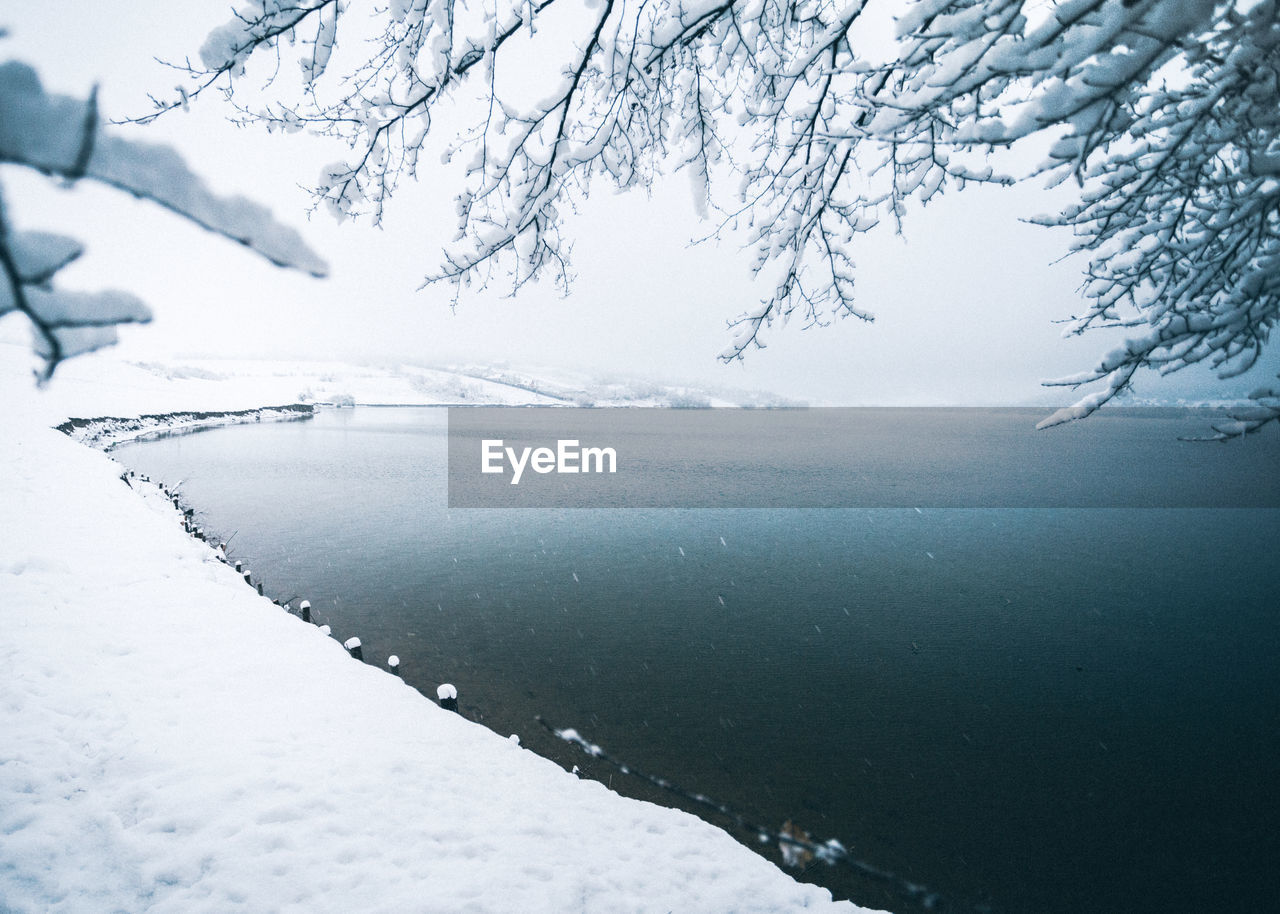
[0,61,326,379]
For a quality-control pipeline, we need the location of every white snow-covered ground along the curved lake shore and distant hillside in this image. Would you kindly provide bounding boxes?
[0,358,859,911]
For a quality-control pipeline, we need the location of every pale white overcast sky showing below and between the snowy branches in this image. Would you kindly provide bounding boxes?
[0,0,1277,405]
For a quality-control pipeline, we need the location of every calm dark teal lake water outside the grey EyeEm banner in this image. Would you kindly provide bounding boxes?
[114,408,1280,913]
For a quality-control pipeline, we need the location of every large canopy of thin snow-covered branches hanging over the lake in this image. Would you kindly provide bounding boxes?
[148,0,1280,427]
